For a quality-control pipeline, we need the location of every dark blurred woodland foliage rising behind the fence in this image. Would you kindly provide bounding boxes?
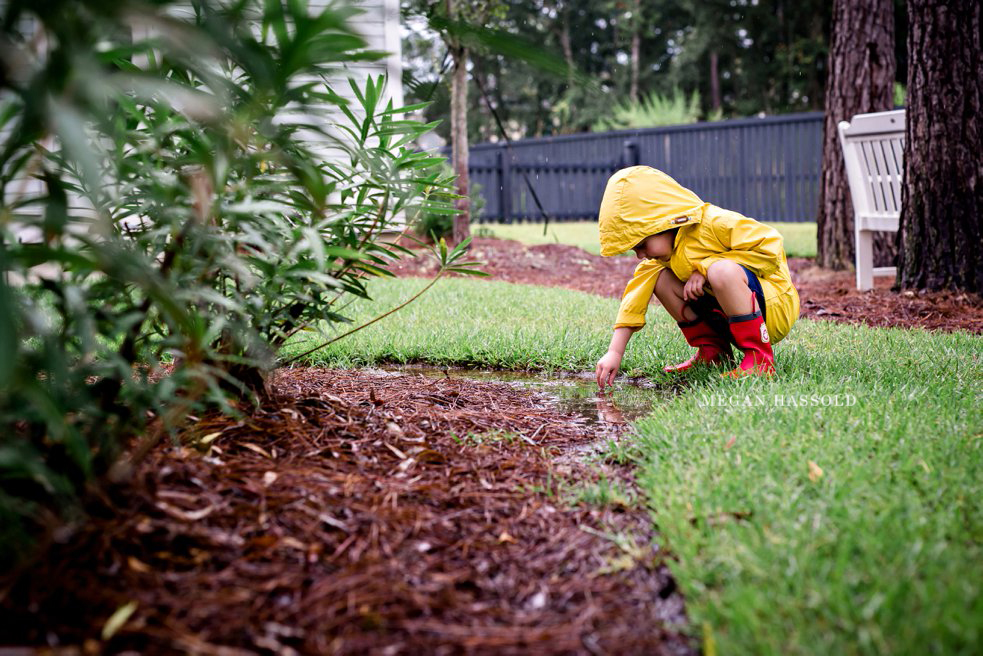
[404,0,906,142]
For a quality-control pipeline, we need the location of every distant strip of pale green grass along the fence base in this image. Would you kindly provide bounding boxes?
[473,221,816,257]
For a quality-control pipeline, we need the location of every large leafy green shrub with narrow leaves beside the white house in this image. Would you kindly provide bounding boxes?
[0,0,472,562]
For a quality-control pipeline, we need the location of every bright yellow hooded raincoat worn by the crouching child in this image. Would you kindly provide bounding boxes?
[599,166,799,344]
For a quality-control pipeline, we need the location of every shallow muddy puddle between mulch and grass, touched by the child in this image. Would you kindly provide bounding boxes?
[374,365,678,439]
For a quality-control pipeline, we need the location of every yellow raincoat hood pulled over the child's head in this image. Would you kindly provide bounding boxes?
[598,166,710,255]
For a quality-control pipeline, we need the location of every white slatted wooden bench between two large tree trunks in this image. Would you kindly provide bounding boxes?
[839,109,905,289]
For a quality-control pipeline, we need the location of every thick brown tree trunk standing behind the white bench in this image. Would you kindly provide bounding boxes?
[816,0,895,269]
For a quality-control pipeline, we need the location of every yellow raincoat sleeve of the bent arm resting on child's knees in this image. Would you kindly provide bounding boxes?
[696,213,784,278]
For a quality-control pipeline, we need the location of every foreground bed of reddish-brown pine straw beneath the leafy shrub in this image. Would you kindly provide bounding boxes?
[0,369,693,655]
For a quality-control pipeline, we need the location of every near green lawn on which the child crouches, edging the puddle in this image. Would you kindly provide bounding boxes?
[291,279,983,654]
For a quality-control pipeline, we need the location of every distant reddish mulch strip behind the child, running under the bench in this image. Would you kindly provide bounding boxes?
[393,238,983,334]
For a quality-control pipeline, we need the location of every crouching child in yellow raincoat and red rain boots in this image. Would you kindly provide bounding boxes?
[596,166,799,389]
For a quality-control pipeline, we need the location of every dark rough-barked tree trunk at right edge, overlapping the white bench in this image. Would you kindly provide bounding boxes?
[898,0,983,294]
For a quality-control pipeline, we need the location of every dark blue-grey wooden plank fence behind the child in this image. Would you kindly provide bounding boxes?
[470,112,823,222]
